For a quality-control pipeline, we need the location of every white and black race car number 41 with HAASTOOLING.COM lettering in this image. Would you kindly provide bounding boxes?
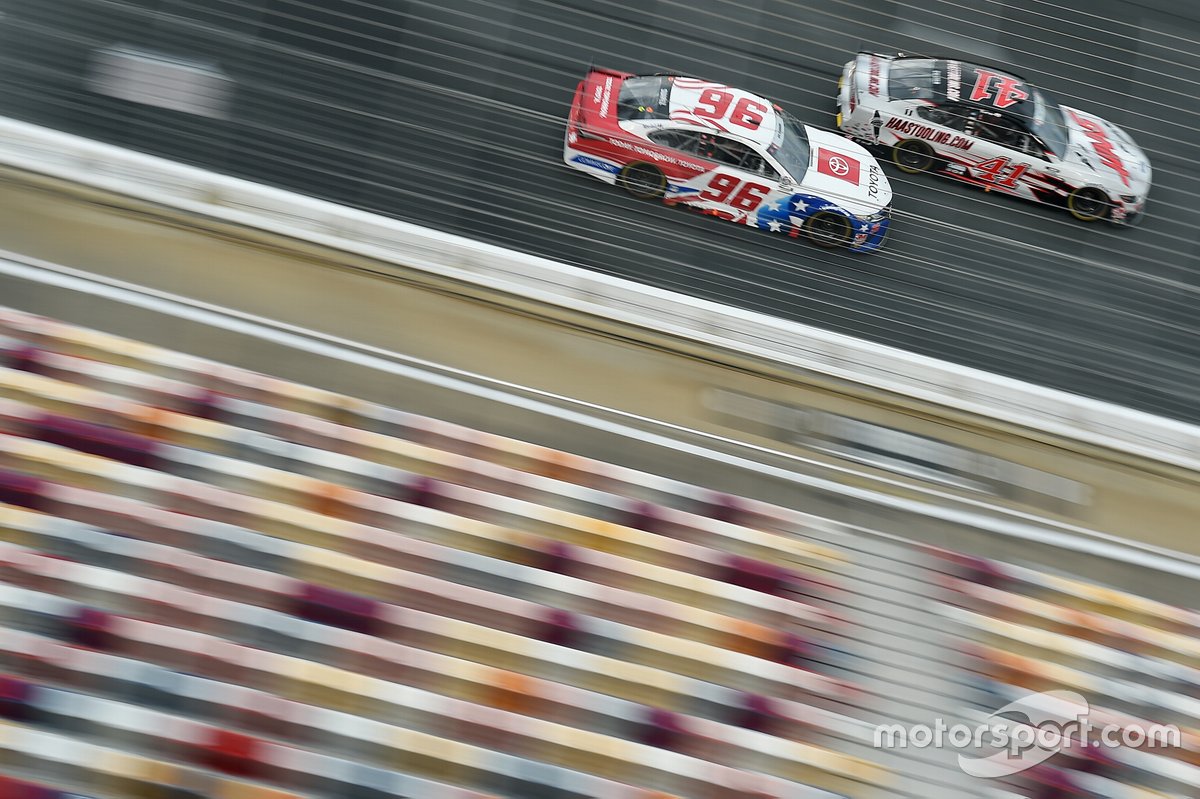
[838,53,1151,224]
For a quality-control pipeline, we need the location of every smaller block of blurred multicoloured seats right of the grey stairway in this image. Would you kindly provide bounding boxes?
[929,548,1200,798]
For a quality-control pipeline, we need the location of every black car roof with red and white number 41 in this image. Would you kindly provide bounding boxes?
[888,58,1037,116]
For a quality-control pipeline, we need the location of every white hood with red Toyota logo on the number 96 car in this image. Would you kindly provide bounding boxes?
[800,125,892,216]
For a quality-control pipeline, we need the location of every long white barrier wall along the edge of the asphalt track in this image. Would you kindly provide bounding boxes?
[0,120,1200,469]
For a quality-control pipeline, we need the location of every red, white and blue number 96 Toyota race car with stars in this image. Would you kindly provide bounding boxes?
[563,68,892,252]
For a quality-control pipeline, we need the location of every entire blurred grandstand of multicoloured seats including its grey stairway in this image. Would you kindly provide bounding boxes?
[0,305,1200,799]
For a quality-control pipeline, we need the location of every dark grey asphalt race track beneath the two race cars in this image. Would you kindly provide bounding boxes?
[0,0,1200,421]
